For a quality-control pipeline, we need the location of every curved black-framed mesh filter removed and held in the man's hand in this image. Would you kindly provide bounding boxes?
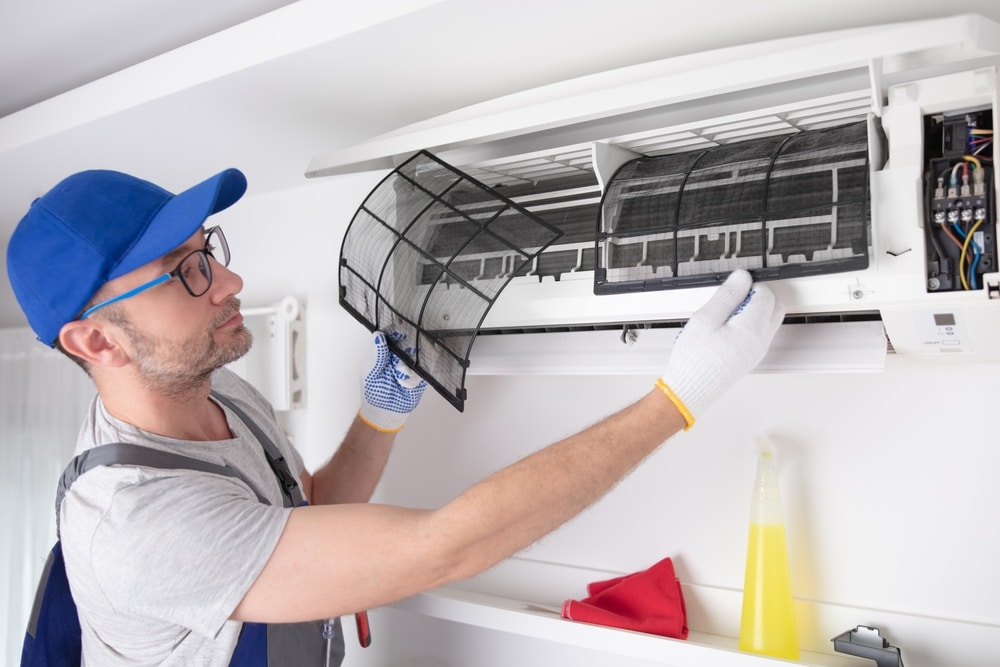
[340,151,562,410]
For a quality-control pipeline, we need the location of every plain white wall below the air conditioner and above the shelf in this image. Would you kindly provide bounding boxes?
[392,366,1000,652]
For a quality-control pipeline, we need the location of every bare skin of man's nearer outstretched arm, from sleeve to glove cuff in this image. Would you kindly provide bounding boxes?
[233,390,685,622]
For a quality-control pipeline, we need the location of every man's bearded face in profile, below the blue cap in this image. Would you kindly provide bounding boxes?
[95,229,253,395]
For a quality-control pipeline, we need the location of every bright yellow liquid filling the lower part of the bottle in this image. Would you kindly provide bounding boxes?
[739,523,799,660]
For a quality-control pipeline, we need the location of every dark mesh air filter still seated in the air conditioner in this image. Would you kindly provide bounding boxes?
[594,122,871,294]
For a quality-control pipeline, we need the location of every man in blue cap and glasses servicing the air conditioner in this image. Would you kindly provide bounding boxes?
[7,170,783,665]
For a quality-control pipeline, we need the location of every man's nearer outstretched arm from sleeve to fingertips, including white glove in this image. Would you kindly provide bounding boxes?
[233,271,783,622]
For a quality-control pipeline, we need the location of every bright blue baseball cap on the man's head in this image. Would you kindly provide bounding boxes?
[7,169,247,347]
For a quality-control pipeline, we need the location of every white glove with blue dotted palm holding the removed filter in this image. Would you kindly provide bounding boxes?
[358,331,427,433]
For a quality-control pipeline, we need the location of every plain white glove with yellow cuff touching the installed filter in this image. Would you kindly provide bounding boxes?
[656,269,785,431]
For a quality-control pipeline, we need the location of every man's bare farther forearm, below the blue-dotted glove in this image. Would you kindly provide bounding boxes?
[310,418,396,505]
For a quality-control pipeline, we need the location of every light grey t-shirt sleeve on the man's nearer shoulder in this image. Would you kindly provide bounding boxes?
[64,468,291,637]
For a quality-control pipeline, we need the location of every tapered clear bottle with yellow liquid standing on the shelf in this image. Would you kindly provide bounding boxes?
[739,435,799,660]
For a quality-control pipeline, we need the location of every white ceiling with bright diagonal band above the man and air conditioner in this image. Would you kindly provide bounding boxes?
[0,0,1000,326]
